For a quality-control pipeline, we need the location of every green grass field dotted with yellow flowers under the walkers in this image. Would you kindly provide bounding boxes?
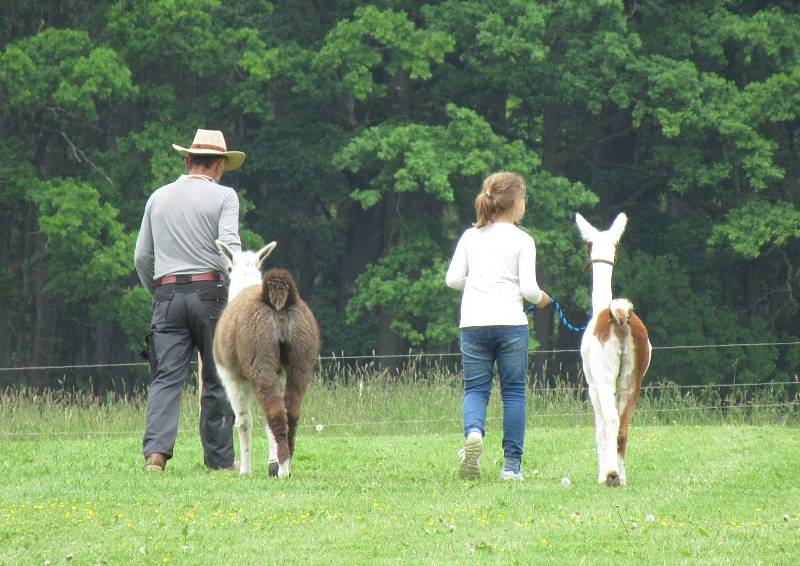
[0,374,800,564]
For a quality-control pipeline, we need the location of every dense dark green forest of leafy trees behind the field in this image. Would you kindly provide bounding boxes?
[0,0,800,386]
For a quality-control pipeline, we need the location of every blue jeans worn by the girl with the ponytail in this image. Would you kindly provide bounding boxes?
[461,325,528,462]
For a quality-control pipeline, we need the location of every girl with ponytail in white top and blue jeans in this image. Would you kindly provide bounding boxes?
[447,173,550,480]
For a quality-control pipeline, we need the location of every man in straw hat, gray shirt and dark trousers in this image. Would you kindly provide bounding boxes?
[134,130,245,471]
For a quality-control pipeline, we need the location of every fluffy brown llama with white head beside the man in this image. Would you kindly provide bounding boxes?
[214,241,320,478]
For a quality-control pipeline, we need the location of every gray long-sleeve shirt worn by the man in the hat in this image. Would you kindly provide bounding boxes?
[133,175,242,295]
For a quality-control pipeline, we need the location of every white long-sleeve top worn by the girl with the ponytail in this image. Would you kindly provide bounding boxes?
[446,222,542,328]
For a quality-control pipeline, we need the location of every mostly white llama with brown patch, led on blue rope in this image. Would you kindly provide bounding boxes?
[575,213,652,487]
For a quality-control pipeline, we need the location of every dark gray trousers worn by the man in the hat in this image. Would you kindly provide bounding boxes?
[143,281,234,468]
